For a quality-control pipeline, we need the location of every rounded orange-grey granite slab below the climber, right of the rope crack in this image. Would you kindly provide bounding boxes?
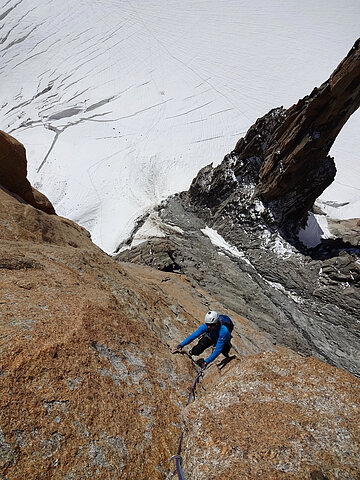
[183,351,360,480]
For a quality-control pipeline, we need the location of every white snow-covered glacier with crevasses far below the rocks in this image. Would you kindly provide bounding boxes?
[0,0,360,252]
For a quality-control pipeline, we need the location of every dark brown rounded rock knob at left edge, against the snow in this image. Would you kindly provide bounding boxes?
[0,130,55,214]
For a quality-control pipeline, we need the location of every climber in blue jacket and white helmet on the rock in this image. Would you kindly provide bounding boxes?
[172,310,234,368]
